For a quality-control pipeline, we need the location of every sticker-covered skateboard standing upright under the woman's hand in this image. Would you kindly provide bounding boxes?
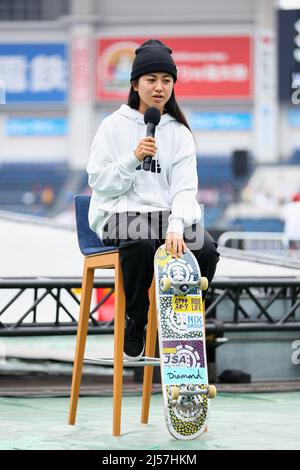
[154,245,216,439]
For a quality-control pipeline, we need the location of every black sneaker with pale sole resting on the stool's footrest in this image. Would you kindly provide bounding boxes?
[124,318,145,361]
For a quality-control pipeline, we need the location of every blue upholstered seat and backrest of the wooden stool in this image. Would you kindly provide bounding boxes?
[75,194,118,256]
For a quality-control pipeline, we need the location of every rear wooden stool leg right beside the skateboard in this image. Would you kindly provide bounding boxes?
[141,278,157,424]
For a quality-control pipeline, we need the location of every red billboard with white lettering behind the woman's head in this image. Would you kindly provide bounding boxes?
[96,36,253,100]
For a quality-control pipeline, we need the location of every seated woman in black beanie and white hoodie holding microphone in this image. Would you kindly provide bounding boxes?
[87,39,219,360]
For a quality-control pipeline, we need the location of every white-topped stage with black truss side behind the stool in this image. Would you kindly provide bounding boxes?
[0,214,300,337]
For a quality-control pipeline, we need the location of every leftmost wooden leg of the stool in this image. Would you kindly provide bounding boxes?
[68,261,94,424]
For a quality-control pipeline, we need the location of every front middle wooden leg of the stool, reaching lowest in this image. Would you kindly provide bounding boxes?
[113,262,125,436]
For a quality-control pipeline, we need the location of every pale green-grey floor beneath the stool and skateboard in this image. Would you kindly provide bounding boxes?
[0,392,300,450]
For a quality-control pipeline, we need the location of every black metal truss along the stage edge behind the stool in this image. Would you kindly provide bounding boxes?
[0,277,300,337]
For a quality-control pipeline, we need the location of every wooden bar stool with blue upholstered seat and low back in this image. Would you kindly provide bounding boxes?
[68,195,158,436]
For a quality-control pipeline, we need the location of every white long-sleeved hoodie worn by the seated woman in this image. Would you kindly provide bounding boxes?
[87,104,201,239]
